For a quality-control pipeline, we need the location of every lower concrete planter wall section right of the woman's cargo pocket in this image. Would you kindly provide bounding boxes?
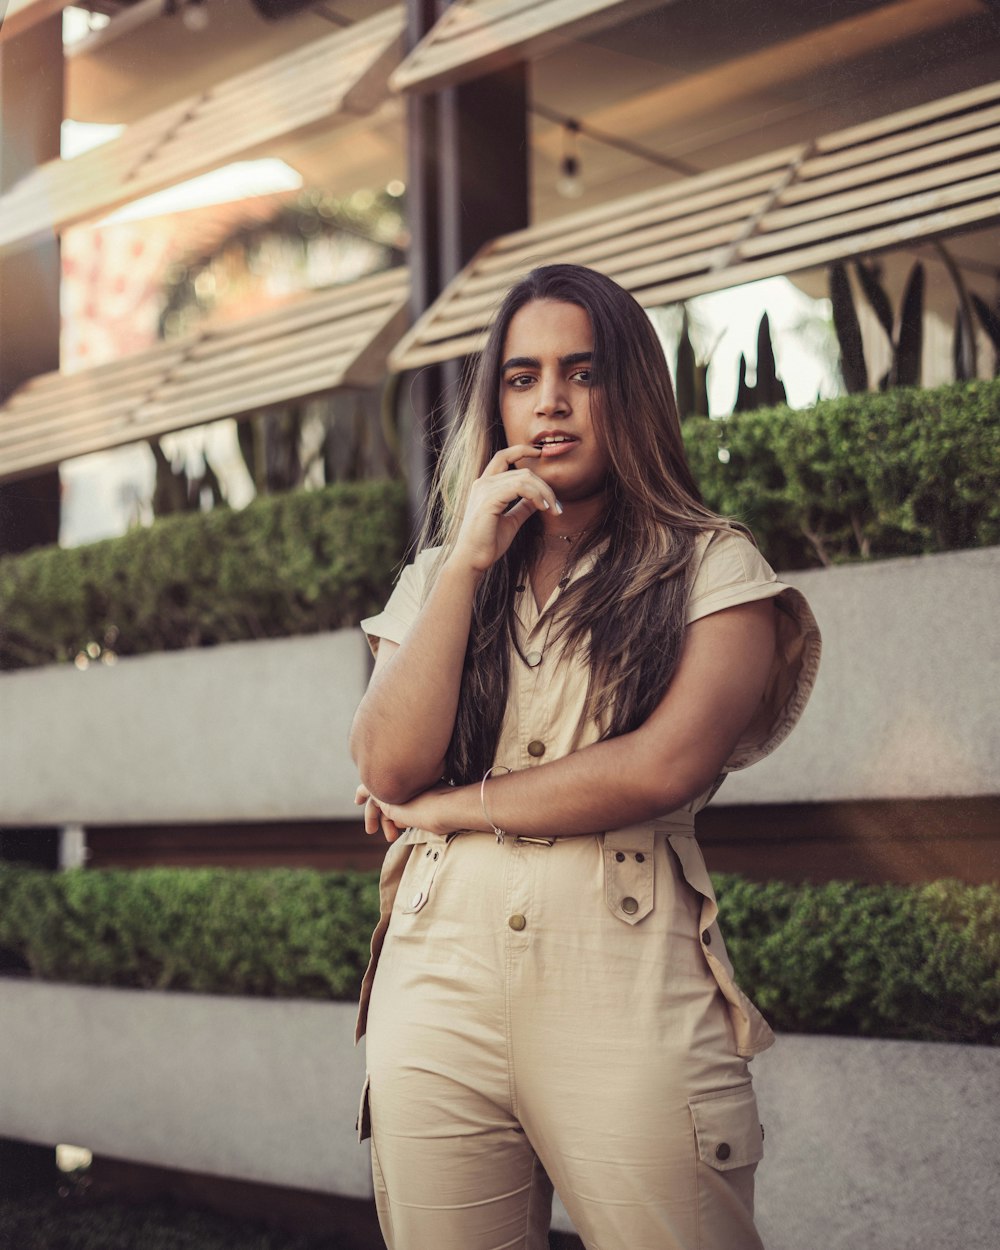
[753,1035,1000,1250]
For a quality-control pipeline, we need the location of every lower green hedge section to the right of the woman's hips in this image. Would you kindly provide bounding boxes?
[715,875,1000,1045]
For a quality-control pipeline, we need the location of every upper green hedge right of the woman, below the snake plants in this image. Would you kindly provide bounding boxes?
[684,381,1000,569]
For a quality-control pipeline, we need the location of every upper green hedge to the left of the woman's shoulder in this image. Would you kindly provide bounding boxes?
[0,481,406,669]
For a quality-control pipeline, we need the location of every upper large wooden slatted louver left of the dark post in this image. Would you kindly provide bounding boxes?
[0,6,403,250]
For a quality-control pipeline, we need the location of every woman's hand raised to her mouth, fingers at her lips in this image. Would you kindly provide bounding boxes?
[451,443,563,573]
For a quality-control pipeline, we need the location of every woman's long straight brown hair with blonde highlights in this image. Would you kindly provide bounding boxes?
[420,265,743,784]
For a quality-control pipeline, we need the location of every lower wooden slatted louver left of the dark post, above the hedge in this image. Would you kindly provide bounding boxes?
[0,269,409,480]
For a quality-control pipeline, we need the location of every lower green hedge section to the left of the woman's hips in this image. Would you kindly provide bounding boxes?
[0,865,379,1000]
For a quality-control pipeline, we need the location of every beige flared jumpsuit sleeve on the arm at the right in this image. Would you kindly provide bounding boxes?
[688,530,821,773]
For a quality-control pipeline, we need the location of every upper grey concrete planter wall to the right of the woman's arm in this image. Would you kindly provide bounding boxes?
[713,548,1000,806]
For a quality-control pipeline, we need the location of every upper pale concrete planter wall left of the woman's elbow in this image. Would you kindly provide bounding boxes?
[0,630,368,826]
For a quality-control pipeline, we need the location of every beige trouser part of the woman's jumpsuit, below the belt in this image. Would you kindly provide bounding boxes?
[368,834,761,1250]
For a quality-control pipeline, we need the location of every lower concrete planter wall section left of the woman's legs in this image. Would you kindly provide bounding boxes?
[0,979,373,1198]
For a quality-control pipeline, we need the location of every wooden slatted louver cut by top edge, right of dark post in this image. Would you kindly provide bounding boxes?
[390,0,670,91]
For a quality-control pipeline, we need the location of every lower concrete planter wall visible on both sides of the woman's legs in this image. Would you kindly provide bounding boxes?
[0,979,1000,1250]
